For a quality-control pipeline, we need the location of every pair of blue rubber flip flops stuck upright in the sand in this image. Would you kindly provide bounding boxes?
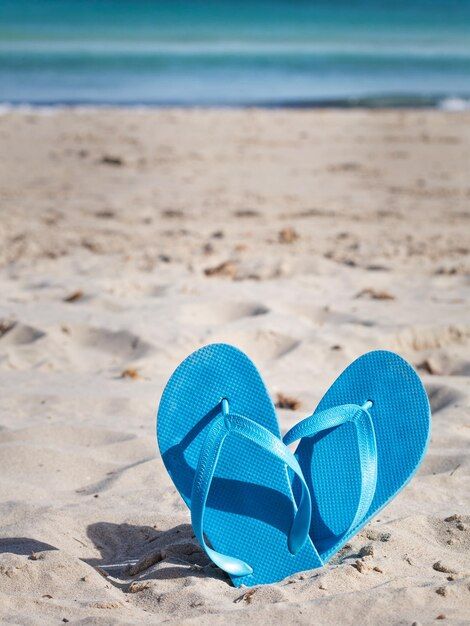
[157,344,430,587]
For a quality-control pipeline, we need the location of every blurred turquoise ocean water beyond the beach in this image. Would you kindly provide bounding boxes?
[0,0,470,108]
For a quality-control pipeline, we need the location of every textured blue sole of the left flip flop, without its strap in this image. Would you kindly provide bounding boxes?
[157,344,322,587]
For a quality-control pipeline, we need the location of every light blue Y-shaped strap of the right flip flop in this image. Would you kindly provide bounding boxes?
[283,400,377,535]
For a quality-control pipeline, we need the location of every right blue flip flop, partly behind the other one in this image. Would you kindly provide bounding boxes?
[283,350,431,562]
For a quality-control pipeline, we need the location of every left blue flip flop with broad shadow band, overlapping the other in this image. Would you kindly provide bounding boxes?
[157,344,322,587]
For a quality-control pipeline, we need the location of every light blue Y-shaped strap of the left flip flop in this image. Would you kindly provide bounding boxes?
[191,399,312,576]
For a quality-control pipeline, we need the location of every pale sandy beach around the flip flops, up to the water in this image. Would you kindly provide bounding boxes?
[0,108,470,626]
